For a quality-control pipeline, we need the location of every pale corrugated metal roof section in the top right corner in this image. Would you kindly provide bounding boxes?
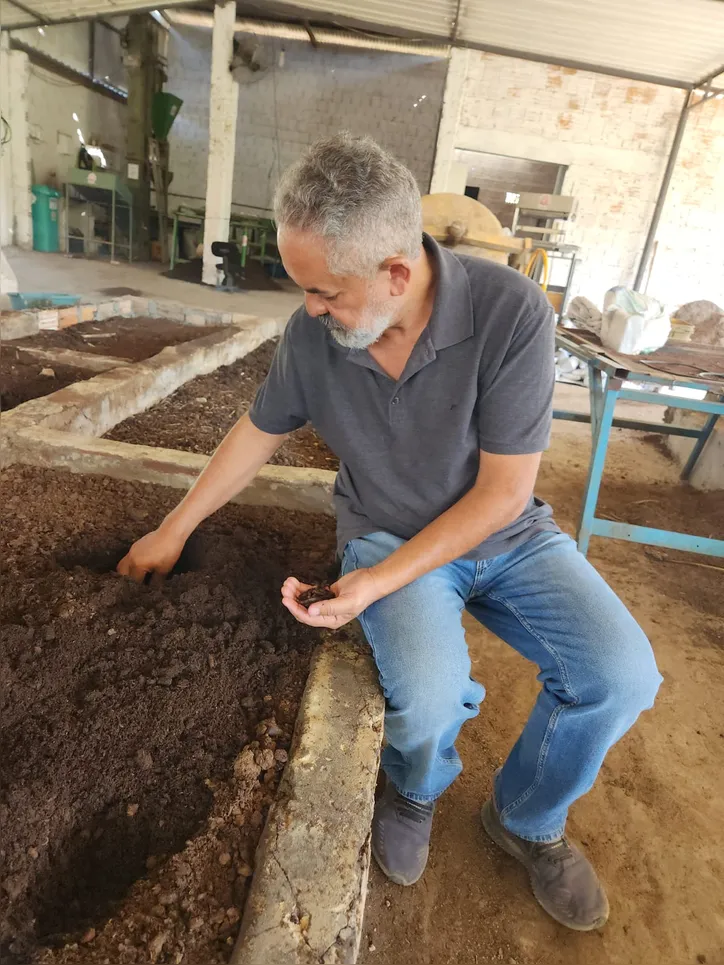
[458,0,724,83]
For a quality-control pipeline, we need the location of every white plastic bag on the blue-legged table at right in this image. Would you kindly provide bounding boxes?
[601,285,671,355]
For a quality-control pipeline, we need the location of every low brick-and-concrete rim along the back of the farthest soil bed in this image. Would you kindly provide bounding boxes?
[0,295,268,342]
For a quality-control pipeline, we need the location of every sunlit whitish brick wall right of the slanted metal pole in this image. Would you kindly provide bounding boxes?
[649,100,724,308]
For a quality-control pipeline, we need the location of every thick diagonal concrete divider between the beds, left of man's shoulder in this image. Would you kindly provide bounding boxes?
[2,318,284,436]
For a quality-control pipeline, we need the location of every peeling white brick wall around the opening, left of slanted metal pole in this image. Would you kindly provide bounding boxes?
[436,51,684,302]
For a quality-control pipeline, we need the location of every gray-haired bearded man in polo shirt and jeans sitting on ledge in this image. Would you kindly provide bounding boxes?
[119,134,661,930]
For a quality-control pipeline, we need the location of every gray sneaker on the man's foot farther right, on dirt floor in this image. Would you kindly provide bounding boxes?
[482,798,608,931]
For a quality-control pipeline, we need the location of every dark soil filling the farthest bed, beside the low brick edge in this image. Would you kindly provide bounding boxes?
[13,318,222,364]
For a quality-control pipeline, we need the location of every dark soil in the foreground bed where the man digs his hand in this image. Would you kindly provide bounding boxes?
[0,467,335,965]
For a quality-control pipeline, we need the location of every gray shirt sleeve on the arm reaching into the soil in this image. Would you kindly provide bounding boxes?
[249,320,309,435]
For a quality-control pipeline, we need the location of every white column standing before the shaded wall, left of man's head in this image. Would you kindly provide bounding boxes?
[201,0,239,285]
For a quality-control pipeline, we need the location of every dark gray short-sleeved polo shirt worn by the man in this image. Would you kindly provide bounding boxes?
[249,235,557,559]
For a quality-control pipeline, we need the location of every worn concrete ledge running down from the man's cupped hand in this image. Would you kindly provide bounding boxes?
[235,630,384,965]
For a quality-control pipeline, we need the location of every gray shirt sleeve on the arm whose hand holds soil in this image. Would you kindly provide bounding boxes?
[478,293,555,455]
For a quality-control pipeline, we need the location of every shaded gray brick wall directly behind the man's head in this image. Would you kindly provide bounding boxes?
[166,28,447,210]
